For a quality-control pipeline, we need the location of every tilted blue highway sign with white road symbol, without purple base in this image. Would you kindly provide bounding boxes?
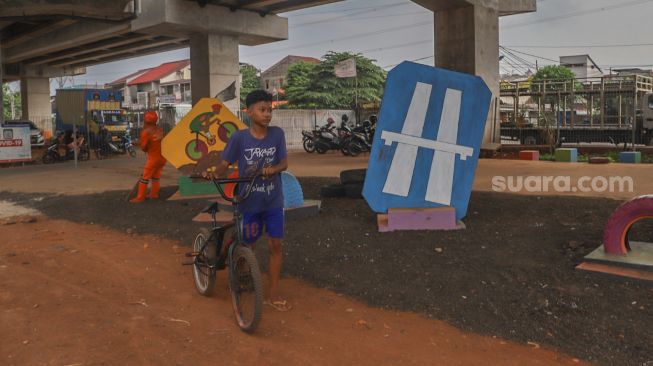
[363,61,492,220]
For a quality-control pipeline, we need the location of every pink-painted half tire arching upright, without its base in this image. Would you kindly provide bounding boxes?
[603,195,653,255]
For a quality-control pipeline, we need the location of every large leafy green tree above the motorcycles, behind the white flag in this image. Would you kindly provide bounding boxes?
[286,51,386,109]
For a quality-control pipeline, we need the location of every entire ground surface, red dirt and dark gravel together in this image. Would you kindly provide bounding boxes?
[0,156,653,366]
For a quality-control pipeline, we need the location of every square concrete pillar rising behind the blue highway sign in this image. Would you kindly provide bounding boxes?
[434,4,501,144]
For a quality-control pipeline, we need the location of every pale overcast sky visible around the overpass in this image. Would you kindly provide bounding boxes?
[47,0,653,89]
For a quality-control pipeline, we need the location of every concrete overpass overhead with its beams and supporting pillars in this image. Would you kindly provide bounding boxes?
[0,0,536,142]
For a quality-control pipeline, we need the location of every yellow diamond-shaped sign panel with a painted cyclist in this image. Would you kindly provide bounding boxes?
[161,98,247,175]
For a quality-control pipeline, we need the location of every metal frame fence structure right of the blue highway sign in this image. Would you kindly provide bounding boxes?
[500,75,653,146]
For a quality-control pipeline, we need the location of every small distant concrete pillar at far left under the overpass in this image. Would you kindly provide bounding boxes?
[20,78,52,131]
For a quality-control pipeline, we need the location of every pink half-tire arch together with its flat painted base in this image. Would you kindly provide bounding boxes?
[576,195,653,281]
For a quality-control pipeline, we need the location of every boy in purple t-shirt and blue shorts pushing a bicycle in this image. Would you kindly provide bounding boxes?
[213,90,291,311]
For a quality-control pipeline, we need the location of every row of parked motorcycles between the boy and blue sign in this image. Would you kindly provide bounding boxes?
[302,115,377,156]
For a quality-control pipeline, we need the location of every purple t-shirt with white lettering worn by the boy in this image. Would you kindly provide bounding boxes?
[222,126,287,213]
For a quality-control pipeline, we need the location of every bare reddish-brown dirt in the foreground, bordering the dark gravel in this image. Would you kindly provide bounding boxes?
[0,216,580,365]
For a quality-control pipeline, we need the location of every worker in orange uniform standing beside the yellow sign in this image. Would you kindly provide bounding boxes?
[129,111,166,203]
